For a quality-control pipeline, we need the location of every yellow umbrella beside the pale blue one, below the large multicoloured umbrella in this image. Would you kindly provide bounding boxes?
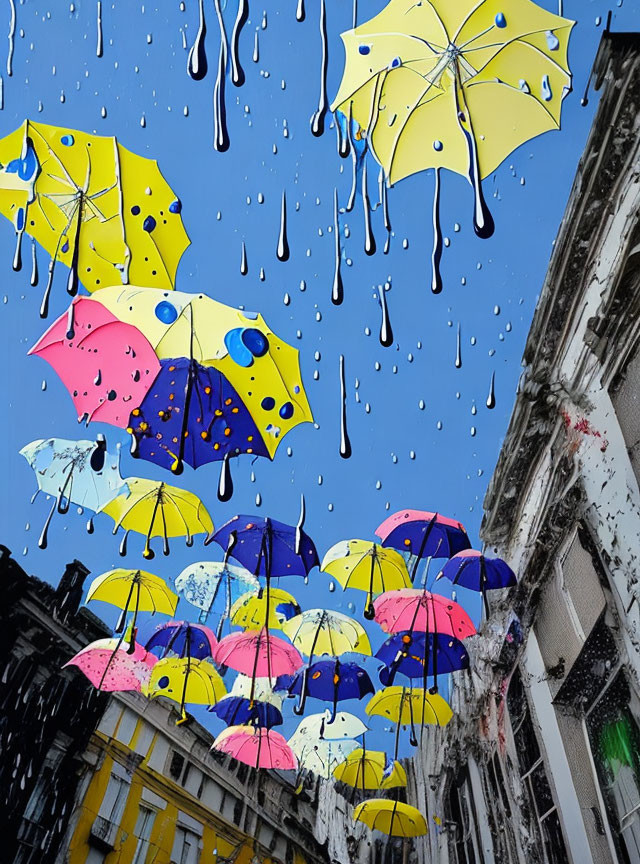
[101,477,213,559]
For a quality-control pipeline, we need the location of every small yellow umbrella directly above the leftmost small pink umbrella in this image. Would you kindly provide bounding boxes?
[87,568,178,632]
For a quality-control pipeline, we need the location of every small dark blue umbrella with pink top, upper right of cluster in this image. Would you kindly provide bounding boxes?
[376,510,471,581]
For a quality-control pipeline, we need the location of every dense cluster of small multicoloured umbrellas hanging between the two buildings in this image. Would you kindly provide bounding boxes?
[62,510,515,837]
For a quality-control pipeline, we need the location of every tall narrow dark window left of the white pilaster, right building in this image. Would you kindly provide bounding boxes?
[507,668,569,864]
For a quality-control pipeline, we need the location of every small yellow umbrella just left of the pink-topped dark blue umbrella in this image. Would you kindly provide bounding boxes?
[320,540,411,621]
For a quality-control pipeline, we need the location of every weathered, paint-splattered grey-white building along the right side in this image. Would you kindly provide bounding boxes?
[412,23,640,864]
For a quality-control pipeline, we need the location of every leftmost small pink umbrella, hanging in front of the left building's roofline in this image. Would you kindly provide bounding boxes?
[63,639,158,692]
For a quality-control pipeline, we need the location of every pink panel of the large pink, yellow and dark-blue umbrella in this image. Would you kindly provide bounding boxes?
[29,297,160,428]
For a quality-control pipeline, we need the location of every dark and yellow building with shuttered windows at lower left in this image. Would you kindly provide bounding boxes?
[0,546,376,864]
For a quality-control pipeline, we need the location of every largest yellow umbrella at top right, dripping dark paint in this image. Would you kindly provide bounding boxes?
[332,0,574,237]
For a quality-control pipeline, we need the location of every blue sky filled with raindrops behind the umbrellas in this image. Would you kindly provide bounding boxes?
[0,0,640,752]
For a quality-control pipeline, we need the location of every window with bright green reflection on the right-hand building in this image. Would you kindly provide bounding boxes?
[586,672,640,864]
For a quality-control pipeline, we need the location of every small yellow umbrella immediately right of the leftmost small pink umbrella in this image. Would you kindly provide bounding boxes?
[146,657,227,723]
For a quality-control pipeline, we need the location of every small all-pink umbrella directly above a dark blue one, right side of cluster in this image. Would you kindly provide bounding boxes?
[373,588,476,639]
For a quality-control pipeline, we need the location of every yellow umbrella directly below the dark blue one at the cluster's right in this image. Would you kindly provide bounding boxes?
[365,687,453,759]
